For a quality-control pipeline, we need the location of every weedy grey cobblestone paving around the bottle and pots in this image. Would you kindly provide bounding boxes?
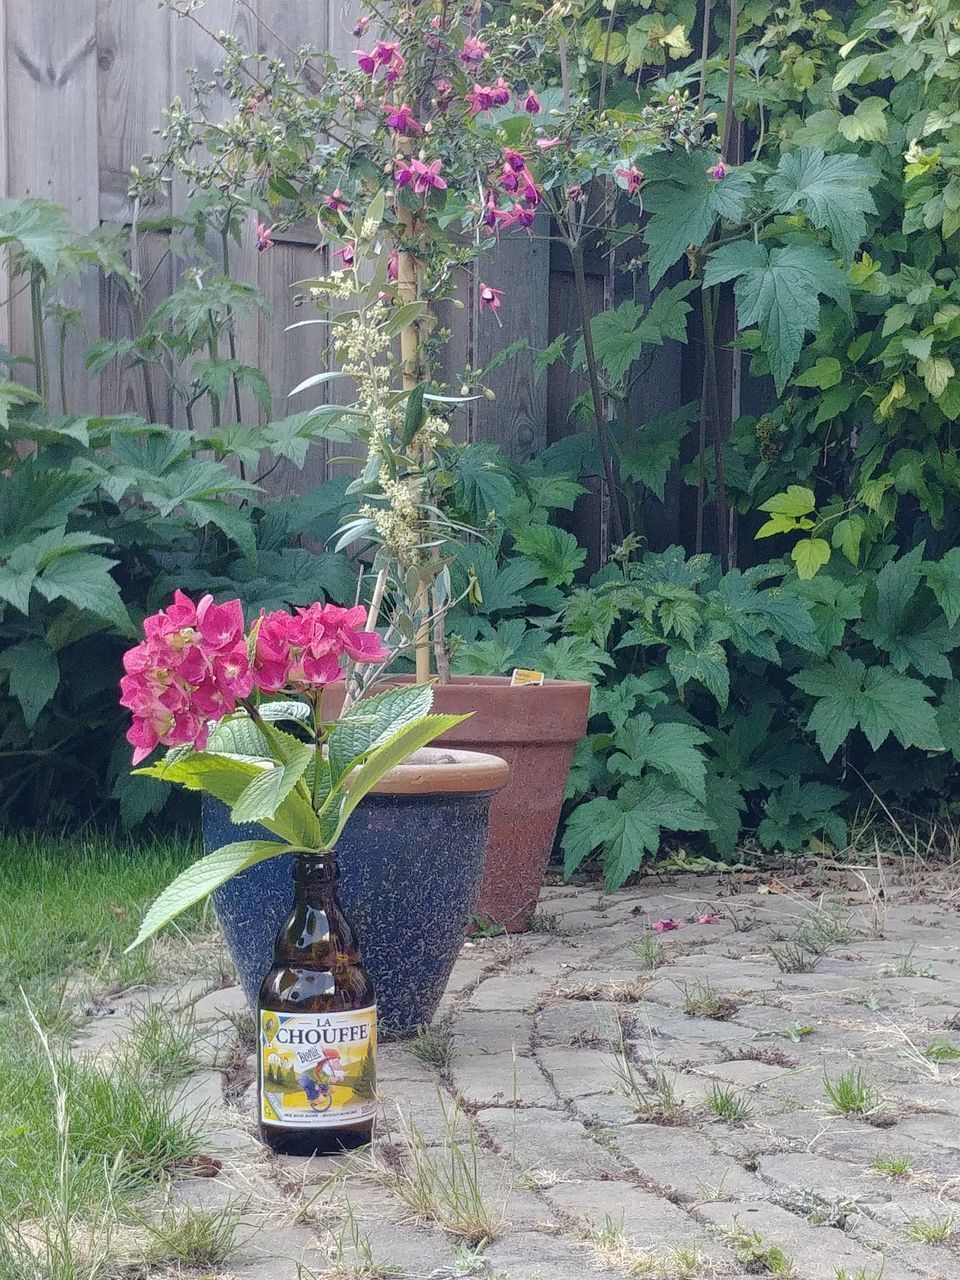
[76,870,960,1280]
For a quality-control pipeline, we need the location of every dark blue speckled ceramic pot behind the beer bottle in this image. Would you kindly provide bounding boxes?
[202,753,507,1037]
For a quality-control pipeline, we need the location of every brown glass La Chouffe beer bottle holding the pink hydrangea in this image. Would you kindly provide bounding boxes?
[257,854,376,1156]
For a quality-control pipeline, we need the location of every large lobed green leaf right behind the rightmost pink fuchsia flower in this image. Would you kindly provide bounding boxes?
[644,150,753,288]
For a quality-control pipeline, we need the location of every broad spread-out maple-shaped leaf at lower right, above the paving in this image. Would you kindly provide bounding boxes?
[790,653,943,760]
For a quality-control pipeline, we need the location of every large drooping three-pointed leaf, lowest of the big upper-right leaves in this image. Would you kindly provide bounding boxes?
[704,241,850,394]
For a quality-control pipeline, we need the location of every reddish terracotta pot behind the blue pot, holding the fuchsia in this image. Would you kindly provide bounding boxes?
[325,676,591,933]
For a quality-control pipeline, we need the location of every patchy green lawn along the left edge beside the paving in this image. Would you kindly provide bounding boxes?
[0,836,219,1280]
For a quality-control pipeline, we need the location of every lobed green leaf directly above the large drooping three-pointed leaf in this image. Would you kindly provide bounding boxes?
[764,147,879,262]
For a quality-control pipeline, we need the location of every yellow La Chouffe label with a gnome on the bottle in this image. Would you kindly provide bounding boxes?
[260,1005,376,1129]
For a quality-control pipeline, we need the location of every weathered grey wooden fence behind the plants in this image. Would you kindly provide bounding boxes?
[0,0,691,562]
